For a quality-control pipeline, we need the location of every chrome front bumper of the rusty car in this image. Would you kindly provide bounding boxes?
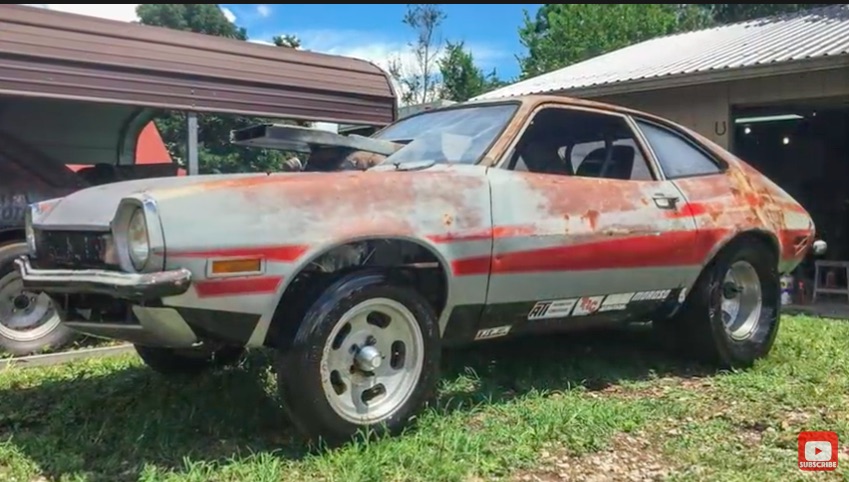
[15,256,192,301]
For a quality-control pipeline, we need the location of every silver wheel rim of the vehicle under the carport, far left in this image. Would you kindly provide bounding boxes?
[0,272,61,342]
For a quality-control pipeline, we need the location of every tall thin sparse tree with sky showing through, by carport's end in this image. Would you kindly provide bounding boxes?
[389,3,445,104]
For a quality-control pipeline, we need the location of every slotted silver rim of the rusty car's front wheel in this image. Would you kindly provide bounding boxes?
[320,298,424,424]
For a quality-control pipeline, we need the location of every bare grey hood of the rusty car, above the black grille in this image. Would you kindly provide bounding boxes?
[33,174,266,229]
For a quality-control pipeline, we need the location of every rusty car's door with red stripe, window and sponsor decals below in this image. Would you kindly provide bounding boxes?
[484,107,696,328]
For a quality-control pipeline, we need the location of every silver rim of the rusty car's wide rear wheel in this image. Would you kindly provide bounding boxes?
[720,261,763,341]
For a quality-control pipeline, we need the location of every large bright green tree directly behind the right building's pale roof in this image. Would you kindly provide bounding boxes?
[519,3,681,79]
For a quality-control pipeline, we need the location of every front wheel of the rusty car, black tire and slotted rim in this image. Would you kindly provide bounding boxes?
[277,272,440,445]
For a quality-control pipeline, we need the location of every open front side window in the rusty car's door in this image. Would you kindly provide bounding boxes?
[511,108,653,180]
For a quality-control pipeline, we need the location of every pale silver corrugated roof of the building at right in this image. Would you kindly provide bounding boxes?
[476,4,849,99]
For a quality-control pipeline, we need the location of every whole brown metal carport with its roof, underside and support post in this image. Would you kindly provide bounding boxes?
[0,5,396,173]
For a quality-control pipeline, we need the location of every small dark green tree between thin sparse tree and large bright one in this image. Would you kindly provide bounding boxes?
[437,41,503,102]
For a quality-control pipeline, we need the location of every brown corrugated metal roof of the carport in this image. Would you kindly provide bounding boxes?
[0,4,396,125]
